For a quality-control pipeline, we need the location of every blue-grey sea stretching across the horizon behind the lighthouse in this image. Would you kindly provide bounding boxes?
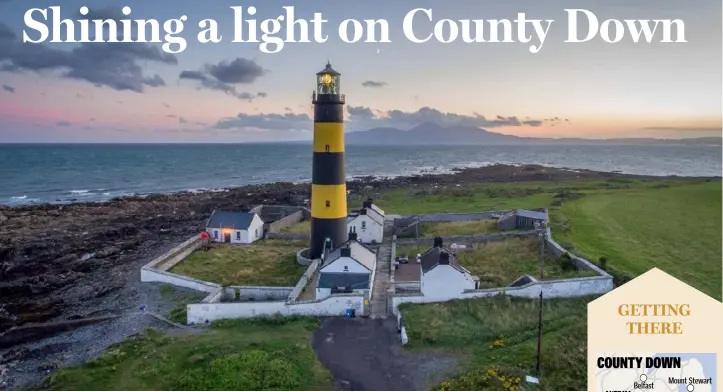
[0,143,721,205]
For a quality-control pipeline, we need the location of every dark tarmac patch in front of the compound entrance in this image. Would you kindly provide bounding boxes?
[312,318,457,391]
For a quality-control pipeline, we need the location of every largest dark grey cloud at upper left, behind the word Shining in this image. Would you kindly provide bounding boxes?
[0,17,178,93]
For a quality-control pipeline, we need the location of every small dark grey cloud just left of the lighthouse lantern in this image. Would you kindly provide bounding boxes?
[178,57,268,101]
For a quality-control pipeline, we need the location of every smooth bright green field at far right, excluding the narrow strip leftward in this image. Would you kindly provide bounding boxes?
[552,181,722,300]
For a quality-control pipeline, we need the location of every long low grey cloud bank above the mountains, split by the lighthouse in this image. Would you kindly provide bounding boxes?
[214,106,554,131]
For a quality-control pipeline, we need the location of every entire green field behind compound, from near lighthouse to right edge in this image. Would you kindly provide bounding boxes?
[375,178,722,300]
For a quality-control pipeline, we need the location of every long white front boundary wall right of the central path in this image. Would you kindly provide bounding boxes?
[392,275,613,315]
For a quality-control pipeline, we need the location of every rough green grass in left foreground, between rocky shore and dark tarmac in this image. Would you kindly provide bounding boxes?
[43,318,332,391]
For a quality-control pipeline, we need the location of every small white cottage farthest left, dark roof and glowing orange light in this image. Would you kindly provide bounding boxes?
[206,211,264,244]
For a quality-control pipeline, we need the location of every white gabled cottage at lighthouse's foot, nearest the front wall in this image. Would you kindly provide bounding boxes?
[316,233,377,299]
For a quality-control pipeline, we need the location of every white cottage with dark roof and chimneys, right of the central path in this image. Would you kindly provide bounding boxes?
[420,237,479,299]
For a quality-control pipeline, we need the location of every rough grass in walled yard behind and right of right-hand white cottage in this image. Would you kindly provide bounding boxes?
[397,238,595,289]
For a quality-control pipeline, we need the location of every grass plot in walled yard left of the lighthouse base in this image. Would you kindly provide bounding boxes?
[171,240,305,287]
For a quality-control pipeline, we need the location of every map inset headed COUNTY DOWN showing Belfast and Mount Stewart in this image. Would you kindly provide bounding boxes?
[595,353,717,392]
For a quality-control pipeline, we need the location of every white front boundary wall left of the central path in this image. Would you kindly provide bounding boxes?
[186,294,364,324]
